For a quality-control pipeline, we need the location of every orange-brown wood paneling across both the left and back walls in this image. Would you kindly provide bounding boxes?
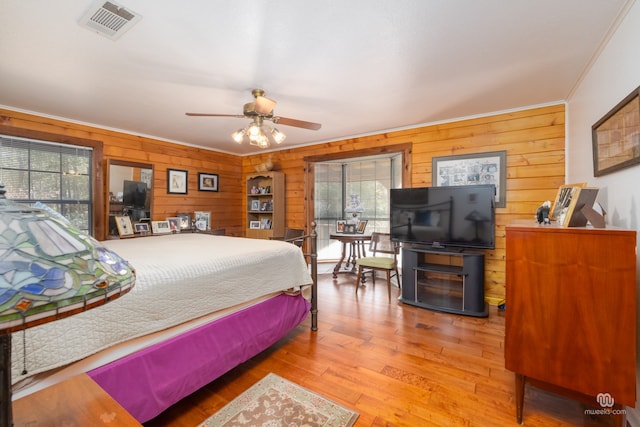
[0,104,565,303]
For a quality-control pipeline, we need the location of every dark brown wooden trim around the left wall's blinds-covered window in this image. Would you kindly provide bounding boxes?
[0,126,107,240]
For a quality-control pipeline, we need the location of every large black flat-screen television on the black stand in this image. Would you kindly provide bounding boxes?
[390,184,496,249]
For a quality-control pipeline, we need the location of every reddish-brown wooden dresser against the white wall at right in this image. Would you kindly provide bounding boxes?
[505,221,636,423]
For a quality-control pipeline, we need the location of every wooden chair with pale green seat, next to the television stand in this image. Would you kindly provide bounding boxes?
[356,232,400,301]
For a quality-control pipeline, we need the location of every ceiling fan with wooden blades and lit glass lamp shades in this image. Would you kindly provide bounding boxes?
[185,89,322,148]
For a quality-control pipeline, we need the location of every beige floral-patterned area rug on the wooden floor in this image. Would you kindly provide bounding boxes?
[199,374,359,427]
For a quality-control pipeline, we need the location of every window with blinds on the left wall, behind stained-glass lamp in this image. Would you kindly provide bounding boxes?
[0,136,92,233]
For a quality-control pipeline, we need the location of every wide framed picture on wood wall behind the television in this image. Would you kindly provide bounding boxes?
[431,151,507,208]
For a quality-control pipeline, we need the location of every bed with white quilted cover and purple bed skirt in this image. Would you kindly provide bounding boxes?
[12,232,317,423]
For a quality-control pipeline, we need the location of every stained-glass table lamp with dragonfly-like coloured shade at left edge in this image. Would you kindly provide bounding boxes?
[0,183,135,426]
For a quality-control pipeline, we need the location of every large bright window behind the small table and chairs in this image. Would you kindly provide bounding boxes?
[314,153,402,260]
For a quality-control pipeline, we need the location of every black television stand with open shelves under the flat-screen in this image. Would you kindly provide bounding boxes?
[400,246,489,317]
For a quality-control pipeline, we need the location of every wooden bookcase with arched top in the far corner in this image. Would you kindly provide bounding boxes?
[245,172,285,239]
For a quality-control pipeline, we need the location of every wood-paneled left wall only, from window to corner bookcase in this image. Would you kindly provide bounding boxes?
[0,109,244,239]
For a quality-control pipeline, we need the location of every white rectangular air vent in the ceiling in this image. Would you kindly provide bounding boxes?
[80,0,142,40]
